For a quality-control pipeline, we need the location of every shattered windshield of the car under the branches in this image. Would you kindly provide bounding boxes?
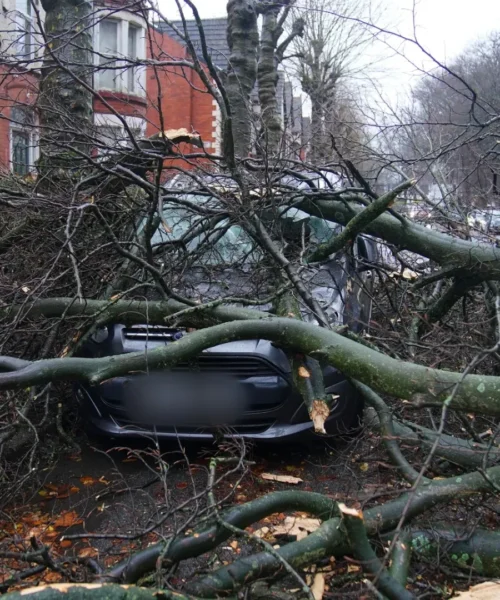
[151,195,339,265]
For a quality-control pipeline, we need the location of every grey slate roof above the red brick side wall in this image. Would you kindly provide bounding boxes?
[158,17,230,70]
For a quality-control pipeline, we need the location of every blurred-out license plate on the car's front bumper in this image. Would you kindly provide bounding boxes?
[125,372,248,427]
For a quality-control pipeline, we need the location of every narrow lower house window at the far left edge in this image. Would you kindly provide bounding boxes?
[10,106,36,176]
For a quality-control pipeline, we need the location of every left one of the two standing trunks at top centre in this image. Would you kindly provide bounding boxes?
[224,0,259,158]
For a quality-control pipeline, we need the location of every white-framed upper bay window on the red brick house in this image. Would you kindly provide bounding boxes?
[94,11,146,97]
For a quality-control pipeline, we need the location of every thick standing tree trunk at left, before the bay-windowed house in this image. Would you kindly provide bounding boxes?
[38,0,93,187]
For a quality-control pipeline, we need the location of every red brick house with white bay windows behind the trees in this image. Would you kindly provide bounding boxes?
[0,0,303,175]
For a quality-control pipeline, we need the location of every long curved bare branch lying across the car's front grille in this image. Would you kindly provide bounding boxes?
[0,318,500,417]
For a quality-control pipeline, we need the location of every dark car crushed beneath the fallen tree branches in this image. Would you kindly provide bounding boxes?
[76,172,376,440]
